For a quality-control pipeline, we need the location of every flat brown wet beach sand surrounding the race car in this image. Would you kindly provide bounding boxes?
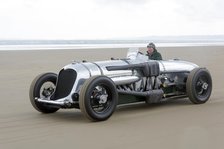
[0,46,224,149]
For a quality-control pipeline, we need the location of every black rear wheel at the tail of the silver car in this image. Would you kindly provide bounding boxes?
[186,68,212,104]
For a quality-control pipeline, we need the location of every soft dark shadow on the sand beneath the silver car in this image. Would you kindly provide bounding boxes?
[38,99,192,123]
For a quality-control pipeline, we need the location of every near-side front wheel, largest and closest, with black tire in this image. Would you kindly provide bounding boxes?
[79,76,118,121]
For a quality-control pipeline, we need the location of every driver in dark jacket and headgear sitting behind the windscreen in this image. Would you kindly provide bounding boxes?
[146,42,162,60]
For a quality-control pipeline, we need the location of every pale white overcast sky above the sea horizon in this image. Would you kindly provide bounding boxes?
[0,0,224,40]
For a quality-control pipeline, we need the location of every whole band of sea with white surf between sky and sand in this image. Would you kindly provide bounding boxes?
[0,35,224,51]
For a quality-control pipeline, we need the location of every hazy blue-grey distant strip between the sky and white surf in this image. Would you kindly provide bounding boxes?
[0,35,224,45]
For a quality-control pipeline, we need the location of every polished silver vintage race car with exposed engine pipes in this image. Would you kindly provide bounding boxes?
[29,48,212,121]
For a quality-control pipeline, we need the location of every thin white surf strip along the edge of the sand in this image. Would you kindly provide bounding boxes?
[0,42,224,51]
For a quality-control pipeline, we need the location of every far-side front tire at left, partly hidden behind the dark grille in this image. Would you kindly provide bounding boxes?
[29,73,59,113]
